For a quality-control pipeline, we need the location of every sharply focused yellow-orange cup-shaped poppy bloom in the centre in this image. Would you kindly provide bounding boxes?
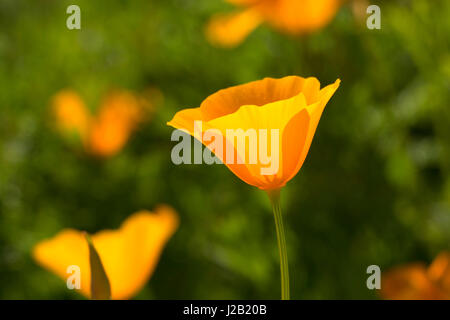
[168,76,340,190]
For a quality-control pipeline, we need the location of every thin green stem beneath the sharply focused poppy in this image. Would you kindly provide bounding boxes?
[267,190,289,300]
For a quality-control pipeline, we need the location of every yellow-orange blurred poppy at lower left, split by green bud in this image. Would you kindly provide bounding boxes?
[32,206,178,299]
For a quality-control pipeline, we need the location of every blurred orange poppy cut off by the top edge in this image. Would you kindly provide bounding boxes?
[206,0,342,47]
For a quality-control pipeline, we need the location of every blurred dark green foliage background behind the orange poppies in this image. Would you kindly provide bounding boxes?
[0,0,450,299]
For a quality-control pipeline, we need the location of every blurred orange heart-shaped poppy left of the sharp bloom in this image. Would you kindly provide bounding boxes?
[52,90,156,157]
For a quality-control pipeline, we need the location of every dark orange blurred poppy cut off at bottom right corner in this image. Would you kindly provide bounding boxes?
[380,252,450,300]
